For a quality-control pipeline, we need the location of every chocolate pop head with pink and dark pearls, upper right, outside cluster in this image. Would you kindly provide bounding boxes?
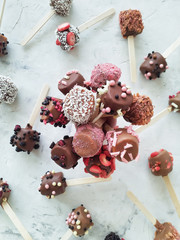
[140,51,168,80]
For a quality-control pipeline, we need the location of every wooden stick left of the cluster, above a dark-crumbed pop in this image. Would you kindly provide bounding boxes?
[28,84,49,127]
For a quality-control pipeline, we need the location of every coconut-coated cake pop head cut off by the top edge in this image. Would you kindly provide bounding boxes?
[50,0,72,16]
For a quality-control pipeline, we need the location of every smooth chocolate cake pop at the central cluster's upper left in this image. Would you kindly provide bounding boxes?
[58,70,85,95]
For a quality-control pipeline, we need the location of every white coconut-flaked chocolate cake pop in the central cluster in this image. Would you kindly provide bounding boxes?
[63,86,95,125]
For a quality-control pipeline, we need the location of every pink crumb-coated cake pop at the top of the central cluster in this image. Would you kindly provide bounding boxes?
[86,63,121,89]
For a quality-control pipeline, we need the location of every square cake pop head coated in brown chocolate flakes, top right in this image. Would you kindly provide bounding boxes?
[119,9,144,38]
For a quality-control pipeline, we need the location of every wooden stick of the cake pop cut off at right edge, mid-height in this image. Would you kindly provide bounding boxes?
[135,107,172,133]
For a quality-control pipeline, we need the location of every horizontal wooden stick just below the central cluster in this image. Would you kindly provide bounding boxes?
[66,176,112,186]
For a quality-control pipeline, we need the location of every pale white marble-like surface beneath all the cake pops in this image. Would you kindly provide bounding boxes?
[0,0,180,240]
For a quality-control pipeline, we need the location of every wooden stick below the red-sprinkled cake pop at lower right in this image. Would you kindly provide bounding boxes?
[163,176,180,218]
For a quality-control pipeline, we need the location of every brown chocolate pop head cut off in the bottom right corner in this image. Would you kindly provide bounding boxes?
[154,221,180,240]
